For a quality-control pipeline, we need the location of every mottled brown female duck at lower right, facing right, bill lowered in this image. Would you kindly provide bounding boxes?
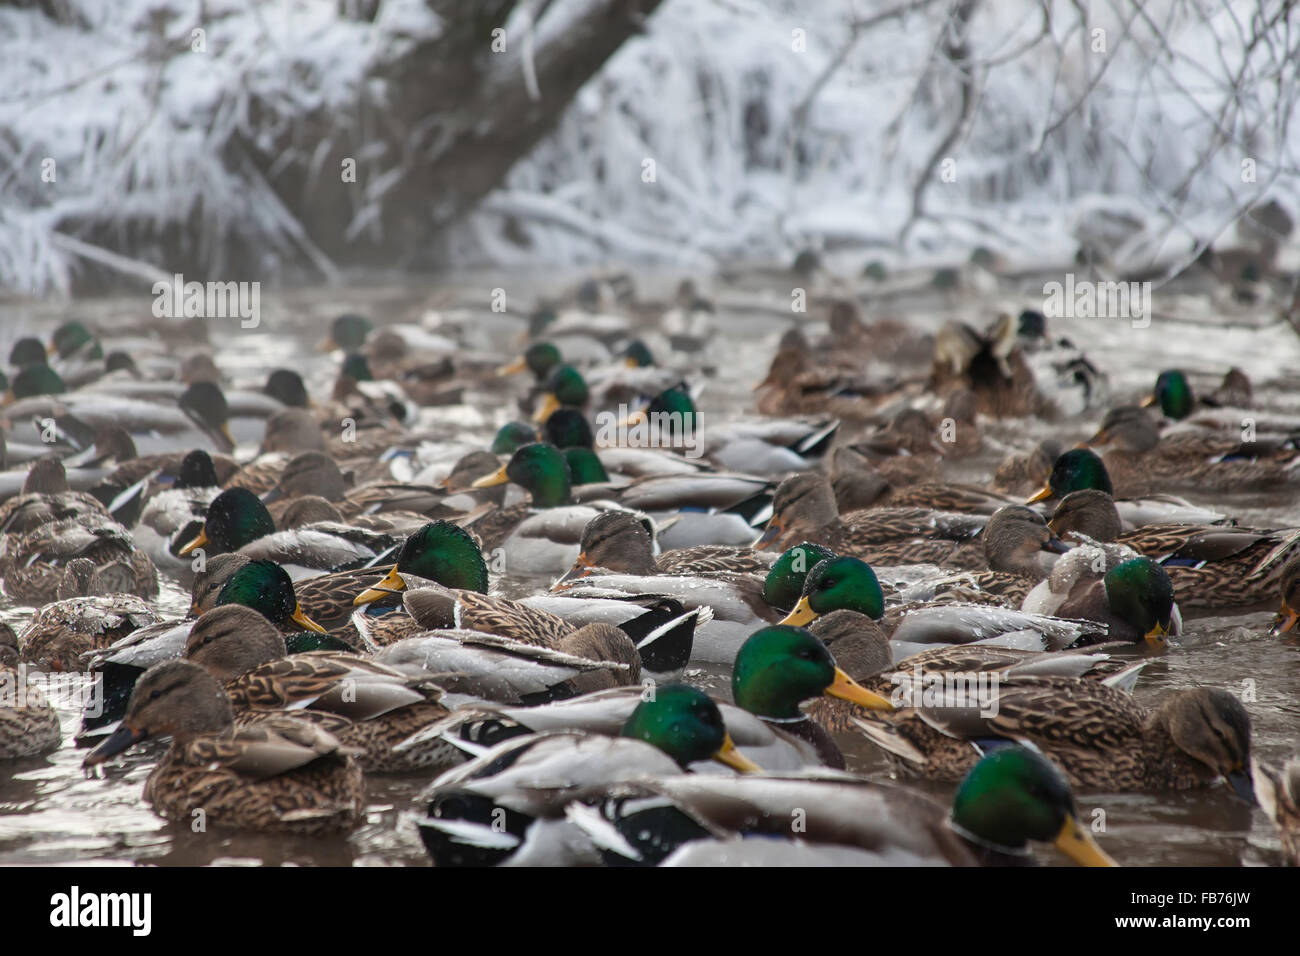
[854,676,1253,800]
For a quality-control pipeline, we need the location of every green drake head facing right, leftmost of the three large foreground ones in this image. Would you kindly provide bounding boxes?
[623,684,759,770]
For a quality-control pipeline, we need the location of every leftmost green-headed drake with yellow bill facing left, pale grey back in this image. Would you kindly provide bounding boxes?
[177,488,397,575]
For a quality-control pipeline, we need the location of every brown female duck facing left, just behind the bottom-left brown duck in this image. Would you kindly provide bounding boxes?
[185,605,459,773]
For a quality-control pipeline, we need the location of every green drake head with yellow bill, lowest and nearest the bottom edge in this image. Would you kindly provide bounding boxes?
[952,745,1115,866]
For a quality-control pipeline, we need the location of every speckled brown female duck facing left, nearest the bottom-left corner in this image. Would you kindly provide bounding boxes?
[86,661,365,836]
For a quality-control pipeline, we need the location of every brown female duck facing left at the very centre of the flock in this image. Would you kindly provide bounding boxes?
[556,511,772,587]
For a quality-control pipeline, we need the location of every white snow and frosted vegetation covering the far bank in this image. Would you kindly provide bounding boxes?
[0,0,1300,294]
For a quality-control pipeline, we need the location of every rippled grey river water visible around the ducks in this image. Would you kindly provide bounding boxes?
[0,276,1300,866]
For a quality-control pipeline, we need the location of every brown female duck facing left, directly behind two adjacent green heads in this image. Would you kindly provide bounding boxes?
[754,472,985,564]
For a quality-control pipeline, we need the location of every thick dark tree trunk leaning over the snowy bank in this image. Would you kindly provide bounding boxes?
[230,0,660,277]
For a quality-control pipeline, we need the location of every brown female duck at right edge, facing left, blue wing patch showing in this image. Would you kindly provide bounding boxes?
[1050,490,1300,609]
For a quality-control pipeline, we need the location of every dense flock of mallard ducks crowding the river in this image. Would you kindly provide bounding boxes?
[0,284,1300,865]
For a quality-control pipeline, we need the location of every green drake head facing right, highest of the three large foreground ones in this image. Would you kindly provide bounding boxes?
[732,624,893,721]
